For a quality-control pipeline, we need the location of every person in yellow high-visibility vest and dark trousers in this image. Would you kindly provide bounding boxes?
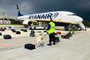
[47,17,55,45]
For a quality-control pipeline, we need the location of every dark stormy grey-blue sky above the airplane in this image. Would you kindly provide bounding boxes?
[0,0,90,21]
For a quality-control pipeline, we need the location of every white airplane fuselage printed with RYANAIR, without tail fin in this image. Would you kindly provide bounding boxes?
[18,11,83,23]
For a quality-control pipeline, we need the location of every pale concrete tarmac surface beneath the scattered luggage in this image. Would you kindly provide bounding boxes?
[0,29,90,60]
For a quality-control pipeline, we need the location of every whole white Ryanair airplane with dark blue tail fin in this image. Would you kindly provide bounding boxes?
[17,5,85,30]
